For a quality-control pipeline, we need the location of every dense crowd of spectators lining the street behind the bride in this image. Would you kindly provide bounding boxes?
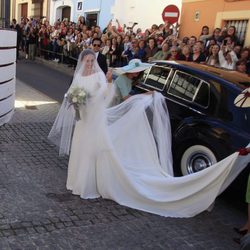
[11,17,250,74]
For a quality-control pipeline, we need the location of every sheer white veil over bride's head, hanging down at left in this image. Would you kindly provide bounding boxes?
[48,49,106,156]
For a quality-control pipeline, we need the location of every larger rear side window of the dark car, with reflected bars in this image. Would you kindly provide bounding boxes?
[168,70,209,107]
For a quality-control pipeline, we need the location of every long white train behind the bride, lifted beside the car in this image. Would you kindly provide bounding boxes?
[96,93,250,217]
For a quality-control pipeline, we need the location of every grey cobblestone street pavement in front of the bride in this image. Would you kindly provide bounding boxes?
[0,77,246,250]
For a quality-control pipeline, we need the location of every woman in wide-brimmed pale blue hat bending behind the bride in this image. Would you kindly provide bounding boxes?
[113,59,153,105]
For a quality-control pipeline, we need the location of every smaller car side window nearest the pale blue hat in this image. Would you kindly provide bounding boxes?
[143,66,171,91]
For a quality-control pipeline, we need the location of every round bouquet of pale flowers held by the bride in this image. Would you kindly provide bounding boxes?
[65,87,87,121]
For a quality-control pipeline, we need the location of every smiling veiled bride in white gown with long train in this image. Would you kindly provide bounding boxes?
[49,50,250,217]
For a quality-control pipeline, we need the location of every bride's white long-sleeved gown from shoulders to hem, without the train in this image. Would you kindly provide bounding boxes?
[66,73,110,198]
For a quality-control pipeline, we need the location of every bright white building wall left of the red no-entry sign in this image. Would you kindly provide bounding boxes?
[111,0,182,31]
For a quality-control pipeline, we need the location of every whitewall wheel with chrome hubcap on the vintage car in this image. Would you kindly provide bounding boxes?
[181,145,217,175]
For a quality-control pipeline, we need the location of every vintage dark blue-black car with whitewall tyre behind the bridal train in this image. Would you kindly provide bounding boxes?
[134,61,250,178]
